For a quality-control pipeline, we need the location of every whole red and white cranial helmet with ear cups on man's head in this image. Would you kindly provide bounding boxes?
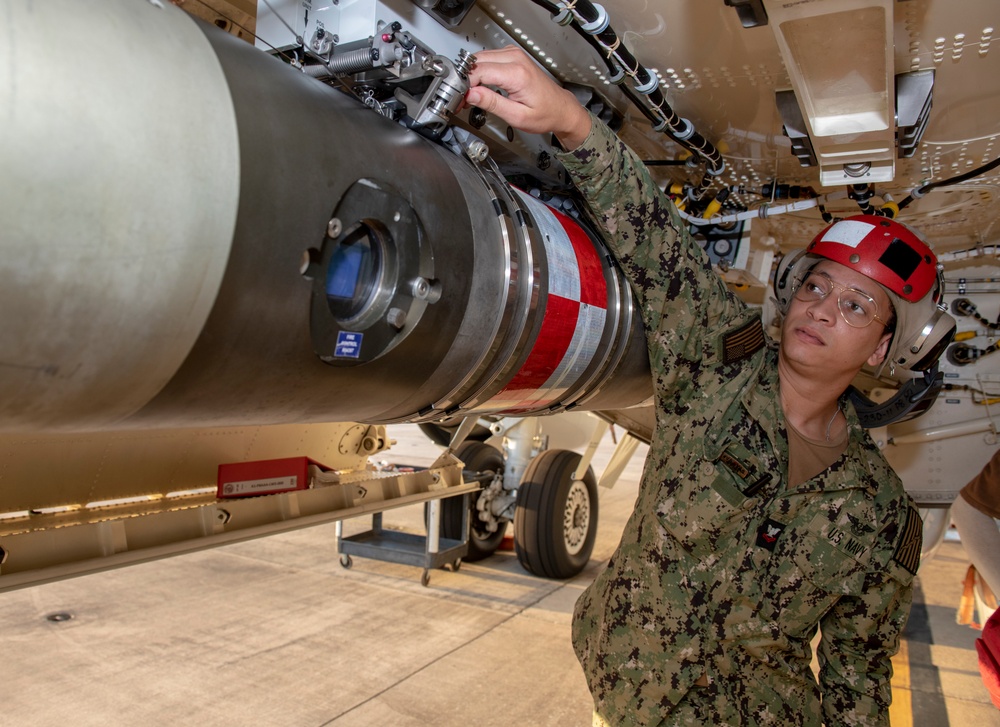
[774,215,955,424]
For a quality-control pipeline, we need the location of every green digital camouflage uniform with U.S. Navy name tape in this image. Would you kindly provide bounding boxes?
[561,120,921,725]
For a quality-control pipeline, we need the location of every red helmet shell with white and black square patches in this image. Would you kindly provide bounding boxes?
[806,215,937,303]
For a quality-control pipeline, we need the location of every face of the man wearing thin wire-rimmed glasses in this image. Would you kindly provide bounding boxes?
[781,260,892,376]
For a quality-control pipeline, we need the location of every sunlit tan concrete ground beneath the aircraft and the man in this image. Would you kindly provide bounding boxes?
[0,426,1000,727]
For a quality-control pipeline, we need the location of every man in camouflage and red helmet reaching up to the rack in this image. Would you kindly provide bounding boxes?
[466,48,954,726]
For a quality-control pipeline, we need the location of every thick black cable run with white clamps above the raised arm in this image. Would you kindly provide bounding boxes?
[533,0,726,200]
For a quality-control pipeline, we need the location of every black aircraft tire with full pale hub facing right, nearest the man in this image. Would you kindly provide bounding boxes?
[514,449,597,579]
